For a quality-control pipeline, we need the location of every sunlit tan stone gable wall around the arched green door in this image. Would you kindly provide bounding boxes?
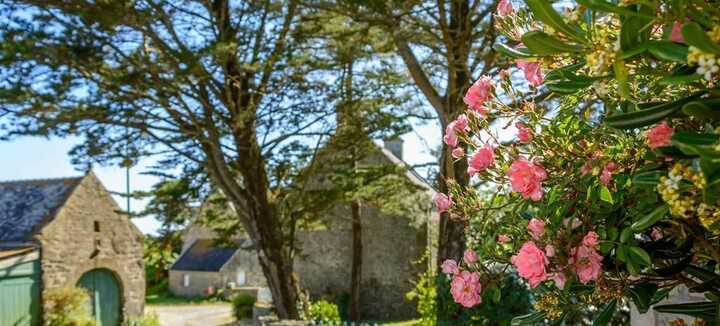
[37,174,145,318]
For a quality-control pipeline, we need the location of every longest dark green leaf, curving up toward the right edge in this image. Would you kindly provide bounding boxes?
[605,91,704,129]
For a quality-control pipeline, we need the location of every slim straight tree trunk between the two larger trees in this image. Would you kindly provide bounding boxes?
[349,200,363,321]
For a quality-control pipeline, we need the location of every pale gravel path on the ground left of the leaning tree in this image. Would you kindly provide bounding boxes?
[146,304,235,326]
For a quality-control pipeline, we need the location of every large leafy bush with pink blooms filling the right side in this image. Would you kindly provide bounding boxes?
[436,0,720,324]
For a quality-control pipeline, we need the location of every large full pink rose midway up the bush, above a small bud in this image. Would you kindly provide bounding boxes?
[507,157,547,201]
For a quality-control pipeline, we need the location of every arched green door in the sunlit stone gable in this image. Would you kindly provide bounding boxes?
[78,269,120,326]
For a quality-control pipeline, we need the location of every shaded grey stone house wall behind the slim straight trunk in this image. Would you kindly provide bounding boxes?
[295,206,427,319]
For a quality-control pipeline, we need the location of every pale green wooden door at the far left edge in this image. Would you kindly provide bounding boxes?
[0,260,40,326]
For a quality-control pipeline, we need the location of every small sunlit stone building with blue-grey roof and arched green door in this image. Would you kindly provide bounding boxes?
[0,172,145,326]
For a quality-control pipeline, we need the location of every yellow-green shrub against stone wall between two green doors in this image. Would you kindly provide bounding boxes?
[44,287,95,326]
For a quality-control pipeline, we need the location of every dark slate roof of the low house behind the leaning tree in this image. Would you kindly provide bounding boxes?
[171,239,238,272]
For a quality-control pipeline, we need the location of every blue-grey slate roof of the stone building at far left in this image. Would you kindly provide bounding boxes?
[0,177,82,243]
